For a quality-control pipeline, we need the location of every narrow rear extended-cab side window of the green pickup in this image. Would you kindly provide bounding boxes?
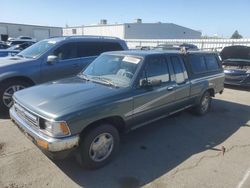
[170,56,187,84]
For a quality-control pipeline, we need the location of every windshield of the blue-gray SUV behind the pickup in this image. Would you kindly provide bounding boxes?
[17,39,57,58]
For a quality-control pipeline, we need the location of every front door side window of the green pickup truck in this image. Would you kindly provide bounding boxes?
[144,57,169,82]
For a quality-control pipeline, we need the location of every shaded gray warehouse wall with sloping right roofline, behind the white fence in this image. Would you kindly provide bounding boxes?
[124,23,201,39]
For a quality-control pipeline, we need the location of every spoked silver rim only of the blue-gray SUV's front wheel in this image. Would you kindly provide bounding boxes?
[3,85,25,108]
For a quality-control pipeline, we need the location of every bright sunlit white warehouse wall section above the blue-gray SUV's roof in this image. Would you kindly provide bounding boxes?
[83,24,124,39]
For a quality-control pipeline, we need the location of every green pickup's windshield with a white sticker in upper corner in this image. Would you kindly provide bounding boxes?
[80,54,142,87]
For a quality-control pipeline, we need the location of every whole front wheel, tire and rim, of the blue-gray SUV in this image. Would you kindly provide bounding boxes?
[0,80,30,113]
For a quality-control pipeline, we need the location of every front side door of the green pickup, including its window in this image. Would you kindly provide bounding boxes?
[133,55,175,125]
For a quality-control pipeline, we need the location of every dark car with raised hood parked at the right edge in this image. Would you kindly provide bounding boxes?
[220,46,250,87]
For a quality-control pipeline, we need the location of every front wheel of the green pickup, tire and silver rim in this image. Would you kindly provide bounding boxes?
[78,123,120,169]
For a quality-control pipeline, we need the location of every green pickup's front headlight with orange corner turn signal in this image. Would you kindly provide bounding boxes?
[42,120,70,137]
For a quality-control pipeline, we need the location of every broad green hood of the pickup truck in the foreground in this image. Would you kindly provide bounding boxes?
[14,77,126,119]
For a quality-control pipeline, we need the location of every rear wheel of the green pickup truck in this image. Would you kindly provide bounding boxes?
[193,91,212,116]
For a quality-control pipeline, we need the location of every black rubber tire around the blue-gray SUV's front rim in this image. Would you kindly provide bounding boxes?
[0,80,31,113]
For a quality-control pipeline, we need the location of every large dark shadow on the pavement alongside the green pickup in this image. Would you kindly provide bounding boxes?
[56,99,250,188]
